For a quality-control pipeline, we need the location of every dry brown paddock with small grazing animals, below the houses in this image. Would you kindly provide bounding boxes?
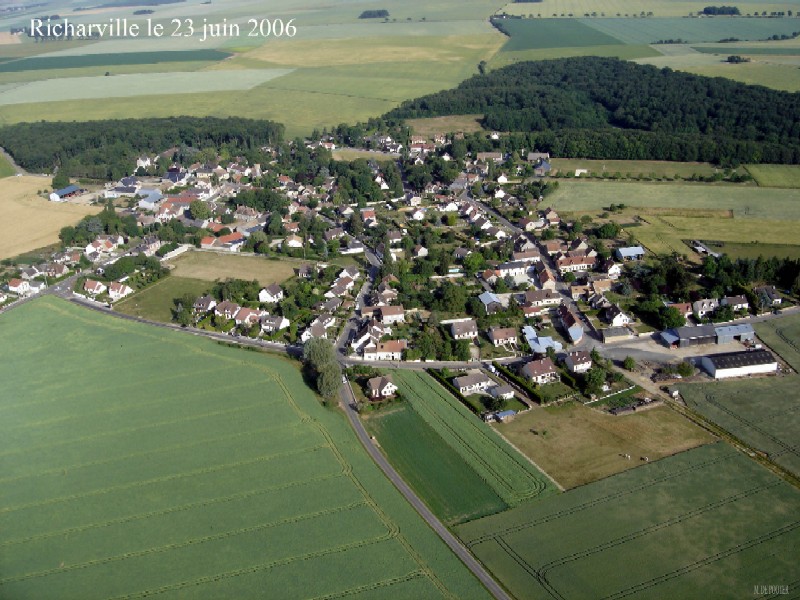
[495,402,712,488]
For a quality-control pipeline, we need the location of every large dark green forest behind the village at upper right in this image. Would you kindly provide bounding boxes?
[385,57,800,164]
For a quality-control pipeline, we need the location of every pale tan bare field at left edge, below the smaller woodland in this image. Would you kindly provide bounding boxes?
[0,177,100,258]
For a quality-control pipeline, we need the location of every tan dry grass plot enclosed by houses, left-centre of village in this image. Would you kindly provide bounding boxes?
[168,251,305,286]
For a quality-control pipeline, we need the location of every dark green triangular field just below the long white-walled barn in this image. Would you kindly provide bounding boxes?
[679,378,800,476]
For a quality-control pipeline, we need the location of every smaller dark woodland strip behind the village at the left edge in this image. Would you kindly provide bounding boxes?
[0,117,283,180]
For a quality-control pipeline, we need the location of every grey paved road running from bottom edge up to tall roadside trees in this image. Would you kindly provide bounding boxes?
[340,381,511,600]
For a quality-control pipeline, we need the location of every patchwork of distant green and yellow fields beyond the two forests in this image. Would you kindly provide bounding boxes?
[0,0,800,136]
